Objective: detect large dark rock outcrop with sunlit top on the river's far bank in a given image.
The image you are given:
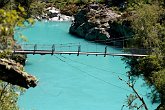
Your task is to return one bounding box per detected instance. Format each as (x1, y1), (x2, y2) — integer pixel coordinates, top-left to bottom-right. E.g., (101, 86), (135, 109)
(69, 4), (120, 40)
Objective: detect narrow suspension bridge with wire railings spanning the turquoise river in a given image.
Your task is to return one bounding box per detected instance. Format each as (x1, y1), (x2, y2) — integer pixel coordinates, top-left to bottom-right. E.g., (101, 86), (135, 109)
(12, 43), (148, 57)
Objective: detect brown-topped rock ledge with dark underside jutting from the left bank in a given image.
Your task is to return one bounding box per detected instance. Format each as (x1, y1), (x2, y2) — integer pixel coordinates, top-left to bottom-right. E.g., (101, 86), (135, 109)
(0, 59), (38, 89)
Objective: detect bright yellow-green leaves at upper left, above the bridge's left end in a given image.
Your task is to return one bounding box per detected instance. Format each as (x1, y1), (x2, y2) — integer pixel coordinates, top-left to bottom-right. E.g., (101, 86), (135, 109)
(0, 8), (25, 49)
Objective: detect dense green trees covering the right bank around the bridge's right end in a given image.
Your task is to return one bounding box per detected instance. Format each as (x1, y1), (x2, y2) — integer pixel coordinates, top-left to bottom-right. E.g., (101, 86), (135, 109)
(120, 0), (165, 106)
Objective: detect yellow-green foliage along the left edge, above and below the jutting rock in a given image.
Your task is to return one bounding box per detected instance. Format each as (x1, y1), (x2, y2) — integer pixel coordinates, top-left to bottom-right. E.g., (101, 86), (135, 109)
(0, 0), (33, 110)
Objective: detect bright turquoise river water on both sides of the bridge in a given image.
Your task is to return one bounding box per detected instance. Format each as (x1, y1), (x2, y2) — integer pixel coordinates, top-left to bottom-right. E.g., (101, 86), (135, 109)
(16, 22), (156, 110)
